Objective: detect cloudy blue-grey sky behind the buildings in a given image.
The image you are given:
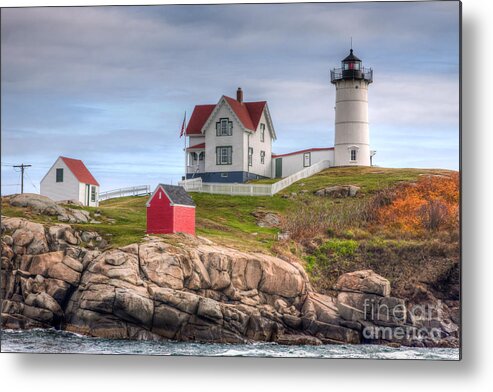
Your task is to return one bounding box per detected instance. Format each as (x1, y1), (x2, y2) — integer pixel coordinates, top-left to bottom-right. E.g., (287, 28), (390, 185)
(1, 1), (459, 195)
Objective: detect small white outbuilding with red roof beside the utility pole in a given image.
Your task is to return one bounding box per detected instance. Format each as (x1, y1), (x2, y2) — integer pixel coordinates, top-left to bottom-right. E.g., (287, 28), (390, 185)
(40, 157), (99, 207)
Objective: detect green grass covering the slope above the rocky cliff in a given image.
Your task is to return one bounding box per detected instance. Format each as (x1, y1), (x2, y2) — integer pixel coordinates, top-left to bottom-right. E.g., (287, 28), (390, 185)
(2, 167), (458, 252)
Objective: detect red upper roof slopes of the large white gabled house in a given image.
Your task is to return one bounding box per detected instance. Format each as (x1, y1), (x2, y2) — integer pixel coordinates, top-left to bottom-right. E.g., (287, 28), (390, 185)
(187, 96), (267, 135)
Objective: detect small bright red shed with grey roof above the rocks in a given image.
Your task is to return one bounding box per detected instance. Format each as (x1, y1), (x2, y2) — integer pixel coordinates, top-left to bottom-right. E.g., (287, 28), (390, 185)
(147, 184), (195, 235)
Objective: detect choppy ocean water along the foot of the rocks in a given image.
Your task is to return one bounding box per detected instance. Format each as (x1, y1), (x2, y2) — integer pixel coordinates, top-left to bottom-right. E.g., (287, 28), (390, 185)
(1, 330), (459, 360)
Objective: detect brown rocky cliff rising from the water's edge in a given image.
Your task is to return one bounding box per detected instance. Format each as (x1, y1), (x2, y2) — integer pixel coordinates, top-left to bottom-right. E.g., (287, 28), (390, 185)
(0, 217), (458, 346)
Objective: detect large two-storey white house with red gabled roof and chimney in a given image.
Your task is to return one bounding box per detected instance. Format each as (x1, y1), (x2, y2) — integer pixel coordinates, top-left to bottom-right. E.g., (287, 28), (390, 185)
(186, 88), (276, 182)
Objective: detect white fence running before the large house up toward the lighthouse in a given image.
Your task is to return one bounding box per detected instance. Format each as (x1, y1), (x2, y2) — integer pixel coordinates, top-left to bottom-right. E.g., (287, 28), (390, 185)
(178, 161), (330, 196)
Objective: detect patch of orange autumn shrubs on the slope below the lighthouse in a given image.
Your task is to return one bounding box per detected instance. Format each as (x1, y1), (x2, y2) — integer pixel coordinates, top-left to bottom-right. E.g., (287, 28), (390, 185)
(377, 173), (459, 232)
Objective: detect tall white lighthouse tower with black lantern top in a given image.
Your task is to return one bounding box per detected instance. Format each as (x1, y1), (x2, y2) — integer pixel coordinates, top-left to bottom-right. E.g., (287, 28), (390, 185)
(330, 49), (373, 166)
